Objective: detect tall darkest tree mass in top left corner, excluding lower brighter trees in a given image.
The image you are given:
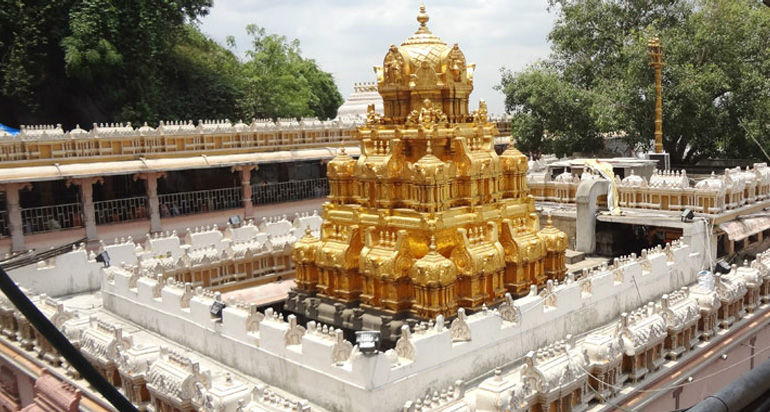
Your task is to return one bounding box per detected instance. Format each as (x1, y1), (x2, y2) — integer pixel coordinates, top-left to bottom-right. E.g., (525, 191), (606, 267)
(0, 0), (216, 127)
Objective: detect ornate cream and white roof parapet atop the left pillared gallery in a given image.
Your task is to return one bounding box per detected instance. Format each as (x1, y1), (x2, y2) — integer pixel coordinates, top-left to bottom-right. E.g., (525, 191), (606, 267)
(0, 117), (510, 167)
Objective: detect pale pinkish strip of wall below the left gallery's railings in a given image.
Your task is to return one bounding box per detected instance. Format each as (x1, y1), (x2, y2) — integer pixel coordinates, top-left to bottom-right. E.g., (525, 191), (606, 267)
(0, 198), (326, 256)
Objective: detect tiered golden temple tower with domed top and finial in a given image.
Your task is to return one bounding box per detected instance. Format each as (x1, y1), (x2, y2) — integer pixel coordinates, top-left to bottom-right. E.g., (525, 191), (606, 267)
(293, 6), (567, 318)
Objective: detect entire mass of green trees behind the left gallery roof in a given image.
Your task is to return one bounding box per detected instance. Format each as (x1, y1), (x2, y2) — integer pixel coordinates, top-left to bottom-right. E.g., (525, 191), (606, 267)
(0, 0), (342, 127)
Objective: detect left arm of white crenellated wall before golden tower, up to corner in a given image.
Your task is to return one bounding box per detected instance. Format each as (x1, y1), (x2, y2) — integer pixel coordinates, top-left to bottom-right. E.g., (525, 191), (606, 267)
(102, 275), (378, 410)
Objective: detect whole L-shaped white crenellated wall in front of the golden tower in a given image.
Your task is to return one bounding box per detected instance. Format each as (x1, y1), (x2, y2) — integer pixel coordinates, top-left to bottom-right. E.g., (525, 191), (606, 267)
(102, 238), (703, 411)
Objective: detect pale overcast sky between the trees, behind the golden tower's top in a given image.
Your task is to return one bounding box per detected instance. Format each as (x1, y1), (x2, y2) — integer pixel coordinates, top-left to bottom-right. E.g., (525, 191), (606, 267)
(201, 0), (554, 114)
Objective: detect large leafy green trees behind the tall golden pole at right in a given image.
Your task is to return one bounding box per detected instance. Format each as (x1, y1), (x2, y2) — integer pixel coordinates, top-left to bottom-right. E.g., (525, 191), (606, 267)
(500, 0), (770, 163)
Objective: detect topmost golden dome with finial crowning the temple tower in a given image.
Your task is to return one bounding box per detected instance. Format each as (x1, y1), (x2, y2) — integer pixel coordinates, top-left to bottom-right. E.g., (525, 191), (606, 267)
(374, 6), (475, 124)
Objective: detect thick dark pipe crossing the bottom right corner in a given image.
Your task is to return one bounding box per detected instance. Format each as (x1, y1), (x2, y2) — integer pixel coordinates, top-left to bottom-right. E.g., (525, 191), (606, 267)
(687, 360), (770, 412)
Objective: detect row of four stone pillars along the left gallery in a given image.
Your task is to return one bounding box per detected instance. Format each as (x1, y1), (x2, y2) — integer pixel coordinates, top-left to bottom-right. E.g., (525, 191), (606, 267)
(0, 165), (257, 252)
